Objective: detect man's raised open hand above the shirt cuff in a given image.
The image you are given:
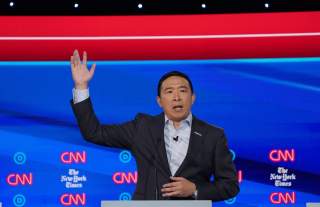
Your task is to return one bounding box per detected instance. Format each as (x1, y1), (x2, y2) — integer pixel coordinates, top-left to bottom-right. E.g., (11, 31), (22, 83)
(70, 50), (96, 89)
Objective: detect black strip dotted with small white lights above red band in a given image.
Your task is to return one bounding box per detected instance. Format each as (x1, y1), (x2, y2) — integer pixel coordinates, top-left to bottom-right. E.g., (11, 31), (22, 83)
(0, 0), (320, 15)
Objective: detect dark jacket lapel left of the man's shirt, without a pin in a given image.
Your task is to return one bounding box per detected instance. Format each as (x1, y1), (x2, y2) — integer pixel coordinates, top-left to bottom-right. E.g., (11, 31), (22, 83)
(151, 113), (171, 175)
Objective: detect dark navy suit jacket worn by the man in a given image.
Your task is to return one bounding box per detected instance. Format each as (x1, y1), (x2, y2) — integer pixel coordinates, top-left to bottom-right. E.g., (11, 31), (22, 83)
(71, 98), (239, 201)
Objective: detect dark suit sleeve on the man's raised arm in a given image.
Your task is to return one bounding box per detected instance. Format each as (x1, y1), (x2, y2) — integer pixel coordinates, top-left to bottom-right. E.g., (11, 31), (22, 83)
(71, 98), (137, 149)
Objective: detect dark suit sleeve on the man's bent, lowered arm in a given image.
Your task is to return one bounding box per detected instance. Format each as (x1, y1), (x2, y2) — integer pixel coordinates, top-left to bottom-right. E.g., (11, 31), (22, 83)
(197, 133), (240, 201)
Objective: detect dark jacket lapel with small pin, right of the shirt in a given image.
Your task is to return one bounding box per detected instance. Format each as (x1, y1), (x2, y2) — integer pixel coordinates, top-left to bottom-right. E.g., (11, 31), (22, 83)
(174, 116), (205, 176)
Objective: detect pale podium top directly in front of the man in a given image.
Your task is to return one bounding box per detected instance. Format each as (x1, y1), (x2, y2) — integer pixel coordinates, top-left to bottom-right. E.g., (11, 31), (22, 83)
(101, 200), (212, 207)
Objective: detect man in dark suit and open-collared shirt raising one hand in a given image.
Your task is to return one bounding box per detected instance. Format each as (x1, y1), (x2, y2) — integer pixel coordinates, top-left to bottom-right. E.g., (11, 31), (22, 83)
(71, 50), (239, 201)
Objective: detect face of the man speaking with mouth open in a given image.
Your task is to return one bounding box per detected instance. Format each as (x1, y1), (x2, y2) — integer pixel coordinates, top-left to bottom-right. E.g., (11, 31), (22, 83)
(157, 76), (195, 122)
